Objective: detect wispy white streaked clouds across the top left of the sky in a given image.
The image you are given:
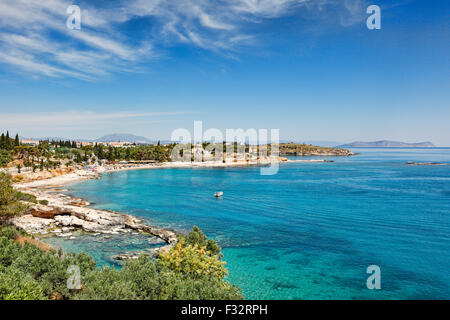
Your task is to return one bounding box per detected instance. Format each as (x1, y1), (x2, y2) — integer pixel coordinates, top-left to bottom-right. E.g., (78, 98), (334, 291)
(0, 0), (363, 81)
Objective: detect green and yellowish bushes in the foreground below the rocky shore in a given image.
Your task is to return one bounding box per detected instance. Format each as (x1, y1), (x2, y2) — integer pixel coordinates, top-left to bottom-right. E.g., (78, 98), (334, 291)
(0, 226), (242, 300)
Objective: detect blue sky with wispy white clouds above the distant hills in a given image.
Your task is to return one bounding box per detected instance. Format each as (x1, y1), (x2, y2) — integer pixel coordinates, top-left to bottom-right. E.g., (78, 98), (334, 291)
(0, 0), (450, 146)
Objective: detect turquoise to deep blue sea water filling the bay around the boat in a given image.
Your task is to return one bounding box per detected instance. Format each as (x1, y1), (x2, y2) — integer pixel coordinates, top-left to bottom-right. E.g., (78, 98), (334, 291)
(43, 149), (450, 299)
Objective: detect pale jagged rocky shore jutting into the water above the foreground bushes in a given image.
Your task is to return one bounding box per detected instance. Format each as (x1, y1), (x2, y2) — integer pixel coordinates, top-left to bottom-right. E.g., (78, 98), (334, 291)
(11, 177), (178, 260)
